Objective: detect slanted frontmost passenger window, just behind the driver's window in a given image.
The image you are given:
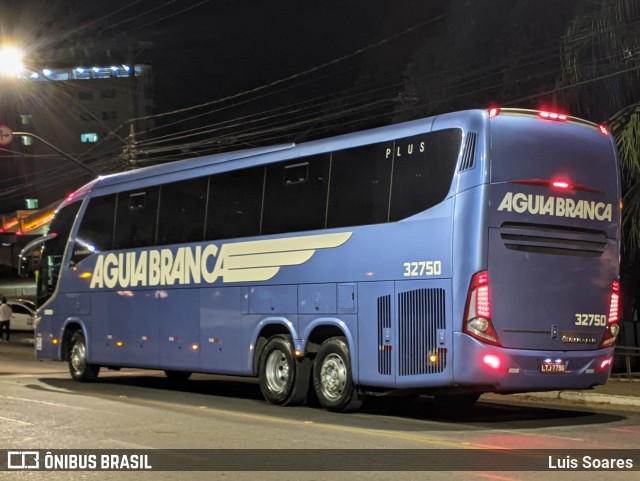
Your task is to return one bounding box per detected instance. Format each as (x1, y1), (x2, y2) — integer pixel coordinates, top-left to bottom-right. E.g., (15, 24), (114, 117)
(71, 194), (116, 263)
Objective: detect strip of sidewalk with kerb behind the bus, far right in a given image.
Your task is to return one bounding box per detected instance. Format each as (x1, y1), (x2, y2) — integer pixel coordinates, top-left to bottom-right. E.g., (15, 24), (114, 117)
(500, 374), (640, 409)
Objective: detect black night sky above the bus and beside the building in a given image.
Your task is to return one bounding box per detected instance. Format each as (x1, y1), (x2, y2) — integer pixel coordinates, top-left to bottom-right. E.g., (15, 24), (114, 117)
(0, 0), (639, 208)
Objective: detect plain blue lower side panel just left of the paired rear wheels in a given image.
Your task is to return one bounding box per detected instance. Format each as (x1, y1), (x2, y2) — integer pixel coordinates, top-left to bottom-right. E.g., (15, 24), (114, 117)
(199, 287), (250, 374)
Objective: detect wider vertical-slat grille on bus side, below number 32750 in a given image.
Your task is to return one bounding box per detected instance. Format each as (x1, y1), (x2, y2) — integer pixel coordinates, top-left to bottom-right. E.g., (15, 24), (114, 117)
(398, 289), (447, 376)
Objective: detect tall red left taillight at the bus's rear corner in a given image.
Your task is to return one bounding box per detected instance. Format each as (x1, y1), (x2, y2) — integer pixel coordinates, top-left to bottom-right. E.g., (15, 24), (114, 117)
(462, 271), (501, 346)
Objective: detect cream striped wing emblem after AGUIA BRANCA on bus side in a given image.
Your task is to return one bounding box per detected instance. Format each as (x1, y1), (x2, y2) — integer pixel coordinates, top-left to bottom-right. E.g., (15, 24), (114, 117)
(214, 232), (352, 282)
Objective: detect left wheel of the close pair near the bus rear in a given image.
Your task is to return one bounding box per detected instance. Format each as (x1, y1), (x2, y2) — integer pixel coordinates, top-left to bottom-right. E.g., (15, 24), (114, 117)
(258, 335), (296, 406)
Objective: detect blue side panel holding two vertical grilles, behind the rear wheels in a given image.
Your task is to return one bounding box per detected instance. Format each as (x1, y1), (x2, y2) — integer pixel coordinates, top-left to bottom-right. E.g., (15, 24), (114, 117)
(358, 279), (452, 389)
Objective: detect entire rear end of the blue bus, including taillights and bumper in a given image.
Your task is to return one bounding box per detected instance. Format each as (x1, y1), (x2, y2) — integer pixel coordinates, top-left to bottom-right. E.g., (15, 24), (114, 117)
(454, 110), (621, 392)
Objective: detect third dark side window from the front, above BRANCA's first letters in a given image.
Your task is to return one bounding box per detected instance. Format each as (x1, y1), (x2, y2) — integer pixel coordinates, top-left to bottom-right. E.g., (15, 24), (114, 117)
(158, 177), (208, 245)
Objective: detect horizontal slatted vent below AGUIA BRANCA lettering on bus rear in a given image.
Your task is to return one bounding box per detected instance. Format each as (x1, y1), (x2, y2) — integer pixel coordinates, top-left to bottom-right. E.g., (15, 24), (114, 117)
(500, 222), (607, 257)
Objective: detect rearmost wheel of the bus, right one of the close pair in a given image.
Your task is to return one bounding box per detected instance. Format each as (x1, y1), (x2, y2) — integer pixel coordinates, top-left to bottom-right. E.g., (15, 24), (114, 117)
(313, 337), (362, 412)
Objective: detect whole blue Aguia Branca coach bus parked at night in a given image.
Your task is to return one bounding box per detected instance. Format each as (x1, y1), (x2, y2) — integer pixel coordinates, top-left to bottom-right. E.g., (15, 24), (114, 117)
(22, 109), (621, 411)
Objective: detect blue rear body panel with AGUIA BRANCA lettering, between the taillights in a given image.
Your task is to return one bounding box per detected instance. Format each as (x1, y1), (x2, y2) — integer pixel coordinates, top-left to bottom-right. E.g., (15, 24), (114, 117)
(480, 115), (620, 351)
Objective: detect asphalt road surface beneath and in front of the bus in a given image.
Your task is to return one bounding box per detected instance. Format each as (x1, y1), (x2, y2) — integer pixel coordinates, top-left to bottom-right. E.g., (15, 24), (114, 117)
(0, 335), (640, 481)
